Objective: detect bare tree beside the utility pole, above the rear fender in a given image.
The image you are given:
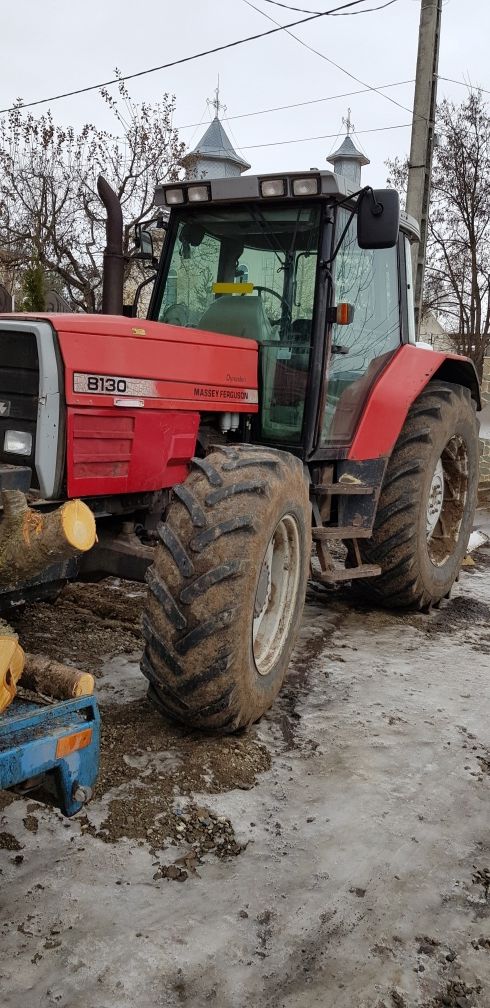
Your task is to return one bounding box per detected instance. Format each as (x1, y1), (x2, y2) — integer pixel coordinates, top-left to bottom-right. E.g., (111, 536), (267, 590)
(388, 92), (490, 375)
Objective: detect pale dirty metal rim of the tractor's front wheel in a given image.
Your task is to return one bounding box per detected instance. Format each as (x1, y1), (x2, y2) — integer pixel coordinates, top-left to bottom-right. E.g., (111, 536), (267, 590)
(252, 514), (300, 675)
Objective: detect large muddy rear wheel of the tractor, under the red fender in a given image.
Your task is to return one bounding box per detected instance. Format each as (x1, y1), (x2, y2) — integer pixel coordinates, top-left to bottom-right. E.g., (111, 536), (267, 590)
(347, 381), (479, 611)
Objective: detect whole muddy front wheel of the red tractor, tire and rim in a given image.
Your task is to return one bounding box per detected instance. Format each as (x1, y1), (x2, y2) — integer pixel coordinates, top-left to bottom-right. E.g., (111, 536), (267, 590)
(141, 445), (312, 734)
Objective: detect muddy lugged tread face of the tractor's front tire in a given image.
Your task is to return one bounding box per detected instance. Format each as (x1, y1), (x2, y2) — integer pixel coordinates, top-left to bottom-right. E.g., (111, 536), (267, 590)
(141, 446), (310, 733)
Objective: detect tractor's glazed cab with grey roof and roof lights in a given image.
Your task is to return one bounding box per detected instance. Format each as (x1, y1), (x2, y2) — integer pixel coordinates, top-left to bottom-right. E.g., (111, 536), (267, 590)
(149, 171), (416, 458)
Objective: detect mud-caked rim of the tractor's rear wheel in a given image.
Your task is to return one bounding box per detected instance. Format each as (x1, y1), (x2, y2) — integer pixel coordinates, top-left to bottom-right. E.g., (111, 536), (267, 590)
(425, 434), (469, 566)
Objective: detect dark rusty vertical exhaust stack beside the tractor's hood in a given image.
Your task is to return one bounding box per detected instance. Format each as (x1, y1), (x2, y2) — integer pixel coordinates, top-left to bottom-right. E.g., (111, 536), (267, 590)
(97, 175), (125, 314)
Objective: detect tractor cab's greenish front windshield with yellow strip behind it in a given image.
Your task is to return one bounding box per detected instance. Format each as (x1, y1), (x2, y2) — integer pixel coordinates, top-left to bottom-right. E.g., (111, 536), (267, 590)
(156, 203), (321, 444)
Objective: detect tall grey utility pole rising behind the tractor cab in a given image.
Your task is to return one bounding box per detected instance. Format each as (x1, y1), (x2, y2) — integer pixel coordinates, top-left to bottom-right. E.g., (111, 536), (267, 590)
(406, 0), (443, 334)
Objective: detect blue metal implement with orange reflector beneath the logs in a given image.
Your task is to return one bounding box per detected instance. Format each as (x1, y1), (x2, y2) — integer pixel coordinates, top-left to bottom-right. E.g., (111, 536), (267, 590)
(0, 696), (100, 815)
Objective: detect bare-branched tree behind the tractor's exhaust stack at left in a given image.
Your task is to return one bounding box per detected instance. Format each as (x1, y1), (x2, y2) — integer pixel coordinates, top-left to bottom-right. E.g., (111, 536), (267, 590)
(0, 74), (185, 311)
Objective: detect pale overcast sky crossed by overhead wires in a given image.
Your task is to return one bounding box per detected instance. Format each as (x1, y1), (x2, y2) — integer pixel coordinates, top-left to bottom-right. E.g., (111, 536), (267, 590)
(0, 0), (490, 185)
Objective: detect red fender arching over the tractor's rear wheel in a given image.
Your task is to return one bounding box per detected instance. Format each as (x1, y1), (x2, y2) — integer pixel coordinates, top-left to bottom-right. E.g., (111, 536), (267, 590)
(348, 344), (481, 462)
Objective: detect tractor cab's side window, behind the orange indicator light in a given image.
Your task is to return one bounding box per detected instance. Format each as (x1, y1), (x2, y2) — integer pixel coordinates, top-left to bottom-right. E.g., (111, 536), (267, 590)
(323, 208), (401, 444)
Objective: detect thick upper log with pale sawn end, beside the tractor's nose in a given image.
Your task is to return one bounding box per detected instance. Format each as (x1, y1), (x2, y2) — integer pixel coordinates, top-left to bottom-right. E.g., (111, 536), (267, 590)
(0, 490), (97, 589)
